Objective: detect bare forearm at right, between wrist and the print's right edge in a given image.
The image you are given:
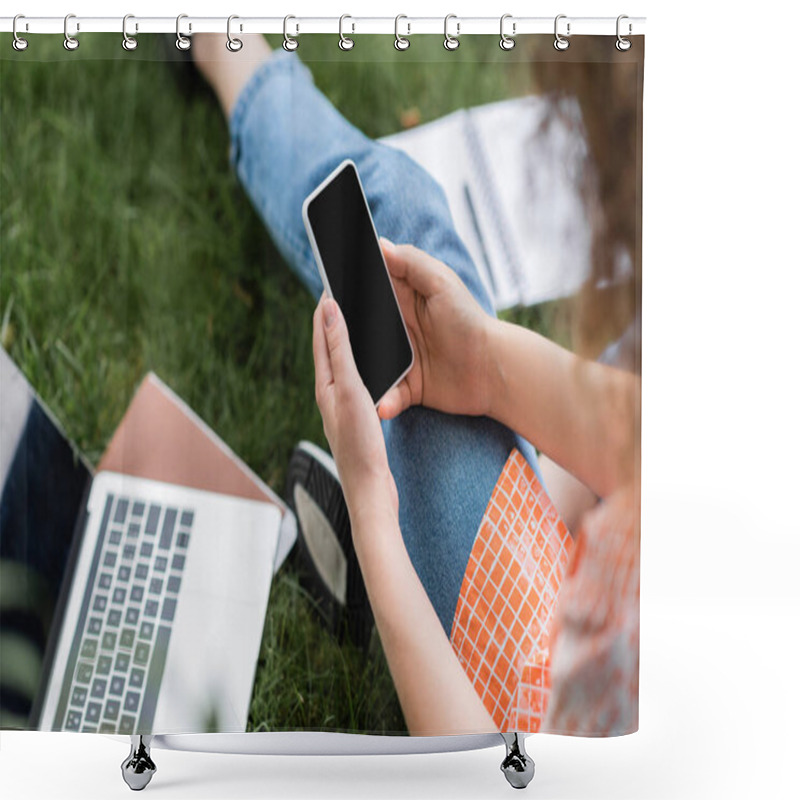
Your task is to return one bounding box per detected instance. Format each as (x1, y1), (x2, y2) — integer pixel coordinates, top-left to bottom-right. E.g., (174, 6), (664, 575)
(489, 321), (640, 497)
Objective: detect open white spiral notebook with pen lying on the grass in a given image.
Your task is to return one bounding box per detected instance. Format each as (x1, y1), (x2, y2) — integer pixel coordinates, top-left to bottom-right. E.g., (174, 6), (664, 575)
(382, 95), (608, 310)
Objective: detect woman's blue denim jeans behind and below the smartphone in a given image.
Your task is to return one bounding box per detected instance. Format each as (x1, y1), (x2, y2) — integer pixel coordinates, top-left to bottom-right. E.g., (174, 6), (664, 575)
(230, 51), (541, 635)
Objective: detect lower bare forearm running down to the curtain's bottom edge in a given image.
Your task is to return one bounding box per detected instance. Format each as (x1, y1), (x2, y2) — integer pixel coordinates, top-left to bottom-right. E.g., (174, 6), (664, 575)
(352, 508), (497, 735)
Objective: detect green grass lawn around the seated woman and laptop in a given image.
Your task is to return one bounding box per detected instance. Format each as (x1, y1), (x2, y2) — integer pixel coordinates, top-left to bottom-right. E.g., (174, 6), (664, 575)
(0, 35), (564, 732)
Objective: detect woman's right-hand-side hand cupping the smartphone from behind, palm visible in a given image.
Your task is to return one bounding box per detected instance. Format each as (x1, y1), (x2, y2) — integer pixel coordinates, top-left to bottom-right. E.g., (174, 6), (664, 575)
(378, 239), (494, 419)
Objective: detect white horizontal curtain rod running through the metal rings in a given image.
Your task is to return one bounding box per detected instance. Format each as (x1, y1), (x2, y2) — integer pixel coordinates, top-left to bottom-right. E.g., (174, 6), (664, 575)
(0, 14), (645, 37)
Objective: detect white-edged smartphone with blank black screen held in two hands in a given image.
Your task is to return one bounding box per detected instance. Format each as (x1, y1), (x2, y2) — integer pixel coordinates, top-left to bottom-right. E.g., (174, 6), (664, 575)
(303, 159), (414, 405)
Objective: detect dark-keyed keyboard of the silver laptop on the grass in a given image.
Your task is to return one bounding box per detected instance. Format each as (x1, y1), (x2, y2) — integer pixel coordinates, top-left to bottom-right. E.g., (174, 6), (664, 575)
(54, 495), (194, 734)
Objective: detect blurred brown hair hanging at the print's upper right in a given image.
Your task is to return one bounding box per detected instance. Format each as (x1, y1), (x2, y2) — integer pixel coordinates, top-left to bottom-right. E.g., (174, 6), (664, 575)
(530, 36), (644, 366)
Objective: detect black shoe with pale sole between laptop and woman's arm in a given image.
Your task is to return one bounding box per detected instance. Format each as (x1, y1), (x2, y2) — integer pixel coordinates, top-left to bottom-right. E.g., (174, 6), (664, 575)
(286, 442), (373, 650)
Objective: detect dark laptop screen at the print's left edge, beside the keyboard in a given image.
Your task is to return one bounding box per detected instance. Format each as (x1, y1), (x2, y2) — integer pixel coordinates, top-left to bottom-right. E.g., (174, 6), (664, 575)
(0, 348), (91, 728)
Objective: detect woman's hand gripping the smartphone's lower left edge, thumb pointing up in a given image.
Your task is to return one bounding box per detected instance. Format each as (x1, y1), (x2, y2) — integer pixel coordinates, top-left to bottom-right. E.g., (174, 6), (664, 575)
(313, 294), (398, 532)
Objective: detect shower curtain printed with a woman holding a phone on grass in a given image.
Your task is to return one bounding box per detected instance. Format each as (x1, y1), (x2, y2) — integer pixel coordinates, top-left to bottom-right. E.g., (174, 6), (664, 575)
(0, 25), (644, 736)
